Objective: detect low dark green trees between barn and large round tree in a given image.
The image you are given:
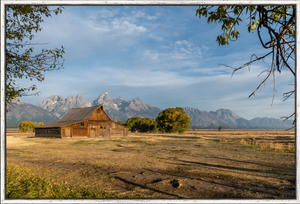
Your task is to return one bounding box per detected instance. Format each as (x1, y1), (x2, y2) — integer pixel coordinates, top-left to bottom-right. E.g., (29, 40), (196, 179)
(123, 117), (157, 132)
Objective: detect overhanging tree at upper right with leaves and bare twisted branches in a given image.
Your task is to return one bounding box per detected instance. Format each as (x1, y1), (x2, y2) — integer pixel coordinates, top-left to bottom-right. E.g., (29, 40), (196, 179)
(196, 5), (296, 123)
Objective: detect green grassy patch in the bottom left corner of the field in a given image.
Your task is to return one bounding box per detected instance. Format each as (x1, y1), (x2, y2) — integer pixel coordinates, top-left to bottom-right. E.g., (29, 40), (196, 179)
(6, 165), (136, 198)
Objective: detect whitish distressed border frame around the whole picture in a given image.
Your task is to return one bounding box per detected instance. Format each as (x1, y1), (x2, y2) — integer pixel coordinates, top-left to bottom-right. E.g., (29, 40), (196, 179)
(0, 0), (300, 203)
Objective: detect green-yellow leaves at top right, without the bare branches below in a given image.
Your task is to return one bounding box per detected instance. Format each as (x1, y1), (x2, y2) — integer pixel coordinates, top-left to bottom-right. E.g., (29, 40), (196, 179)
(196, 5), (295, 45)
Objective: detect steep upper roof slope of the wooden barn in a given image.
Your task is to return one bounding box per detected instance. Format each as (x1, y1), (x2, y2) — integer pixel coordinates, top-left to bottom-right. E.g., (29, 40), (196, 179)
(59, 105), (103, 122)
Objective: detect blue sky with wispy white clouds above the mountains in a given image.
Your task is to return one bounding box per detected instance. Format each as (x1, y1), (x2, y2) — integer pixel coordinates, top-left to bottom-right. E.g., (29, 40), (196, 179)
(18, 6), (294, 119)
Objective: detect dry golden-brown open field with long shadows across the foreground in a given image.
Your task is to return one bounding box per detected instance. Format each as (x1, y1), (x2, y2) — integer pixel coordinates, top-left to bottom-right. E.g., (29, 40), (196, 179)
(6, 130), (295, 199)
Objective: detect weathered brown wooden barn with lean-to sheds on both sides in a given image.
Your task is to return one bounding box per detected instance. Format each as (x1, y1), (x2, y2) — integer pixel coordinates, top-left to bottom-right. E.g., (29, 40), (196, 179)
(35, 105), (128, 139)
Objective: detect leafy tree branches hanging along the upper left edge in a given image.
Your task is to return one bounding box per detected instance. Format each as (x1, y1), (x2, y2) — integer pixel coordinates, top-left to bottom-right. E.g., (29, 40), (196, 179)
(5, 5), (65, 105)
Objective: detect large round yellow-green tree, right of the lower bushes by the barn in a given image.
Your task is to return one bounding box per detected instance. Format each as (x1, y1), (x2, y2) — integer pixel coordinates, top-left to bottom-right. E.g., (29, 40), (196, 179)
(156, 107), (191, 133)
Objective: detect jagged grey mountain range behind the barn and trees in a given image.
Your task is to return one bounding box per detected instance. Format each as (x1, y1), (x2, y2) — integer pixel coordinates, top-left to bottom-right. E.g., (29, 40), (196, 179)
(7, 91), (292, 129)
